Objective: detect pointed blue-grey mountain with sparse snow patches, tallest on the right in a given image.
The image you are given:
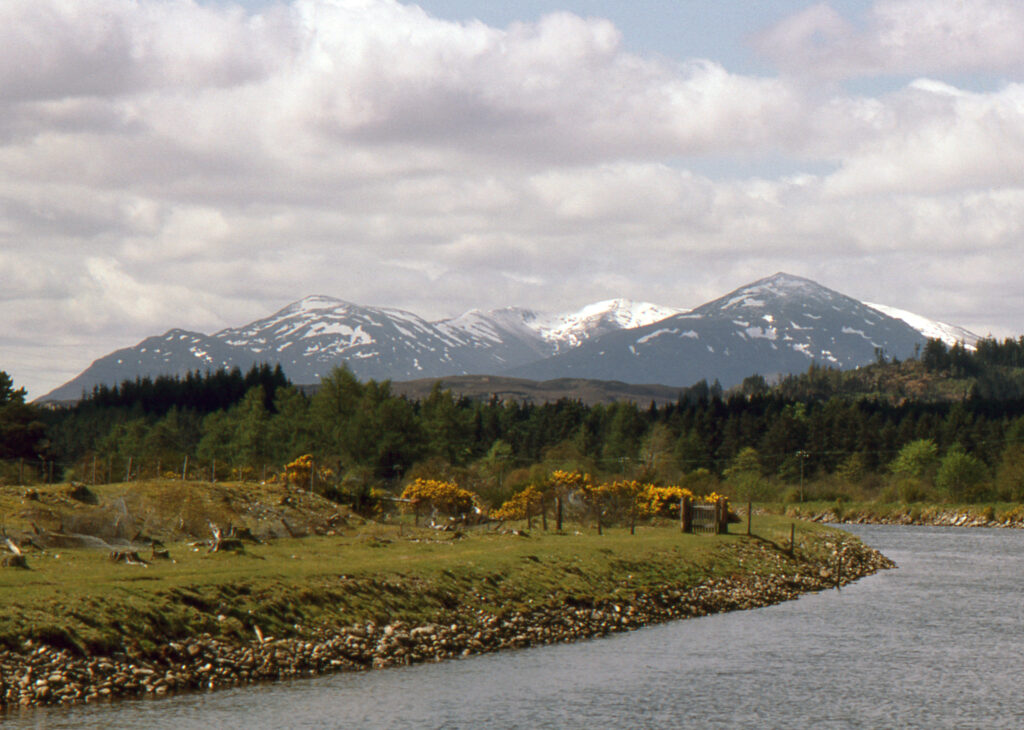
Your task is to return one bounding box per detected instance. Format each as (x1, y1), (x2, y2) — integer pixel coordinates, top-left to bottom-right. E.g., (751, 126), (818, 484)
(510, 273), (942, 387)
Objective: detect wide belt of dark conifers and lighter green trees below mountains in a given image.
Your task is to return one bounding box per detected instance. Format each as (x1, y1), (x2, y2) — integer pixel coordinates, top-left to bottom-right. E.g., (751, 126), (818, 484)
(6, 338), (1024, 508)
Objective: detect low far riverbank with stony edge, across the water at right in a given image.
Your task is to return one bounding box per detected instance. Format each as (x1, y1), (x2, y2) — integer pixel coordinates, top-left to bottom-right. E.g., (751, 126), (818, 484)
(774, 502), (1024, 529)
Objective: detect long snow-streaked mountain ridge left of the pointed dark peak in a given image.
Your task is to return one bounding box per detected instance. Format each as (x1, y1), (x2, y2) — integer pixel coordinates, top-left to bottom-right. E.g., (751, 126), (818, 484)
(42, 296), (671, 400)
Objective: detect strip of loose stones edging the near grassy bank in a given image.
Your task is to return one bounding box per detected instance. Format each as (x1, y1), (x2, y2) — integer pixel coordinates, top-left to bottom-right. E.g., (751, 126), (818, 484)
(0, 541), (894, 712)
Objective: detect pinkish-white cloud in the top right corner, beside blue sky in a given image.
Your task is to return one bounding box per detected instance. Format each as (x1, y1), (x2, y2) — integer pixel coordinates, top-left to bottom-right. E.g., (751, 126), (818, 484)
(757, 0), (1024, 79)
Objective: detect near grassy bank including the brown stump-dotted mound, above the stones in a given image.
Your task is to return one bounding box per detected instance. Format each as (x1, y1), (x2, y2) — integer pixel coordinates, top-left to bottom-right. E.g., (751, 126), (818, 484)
(0, 482), (868, 653)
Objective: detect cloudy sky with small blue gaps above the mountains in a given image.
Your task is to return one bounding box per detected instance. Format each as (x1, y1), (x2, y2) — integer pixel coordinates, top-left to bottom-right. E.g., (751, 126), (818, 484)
(6, 0), (1024, 397)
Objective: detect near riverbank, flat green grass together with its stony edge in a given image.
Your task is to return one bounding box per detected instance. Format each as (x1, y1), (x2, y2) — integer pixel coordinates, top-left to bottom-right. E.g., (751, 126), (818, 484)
(0, 511), (891, 710)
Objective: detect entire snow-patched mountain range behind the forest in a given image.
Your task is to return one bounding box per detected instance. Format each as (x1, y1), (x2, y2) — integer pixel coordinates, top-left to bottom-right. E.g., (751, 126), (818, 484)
(40, 273), (978, 401)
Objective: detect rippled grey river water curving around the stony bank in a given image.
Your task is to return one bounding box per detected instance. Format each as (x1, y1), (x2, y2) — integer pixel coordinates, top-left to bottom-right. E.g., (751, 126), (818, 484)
(4, 526), (1024, 730)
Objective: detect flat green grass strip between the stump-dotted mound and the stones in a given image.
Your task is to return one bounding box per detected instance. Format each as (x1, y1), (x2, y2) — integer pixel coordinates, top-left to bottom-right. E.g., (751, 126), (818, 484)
(0, 517), (835, 653)
